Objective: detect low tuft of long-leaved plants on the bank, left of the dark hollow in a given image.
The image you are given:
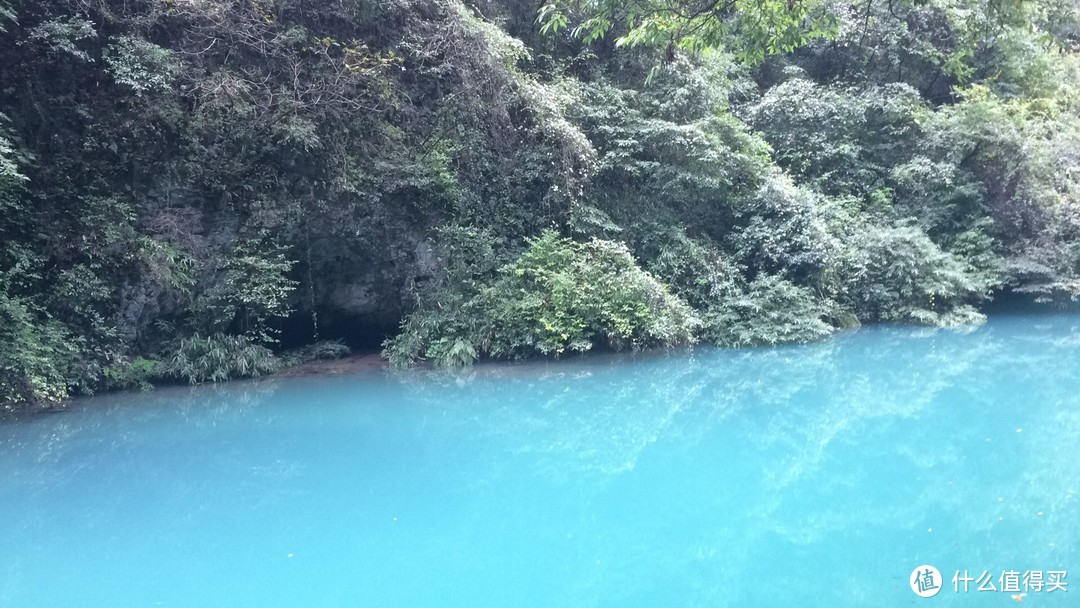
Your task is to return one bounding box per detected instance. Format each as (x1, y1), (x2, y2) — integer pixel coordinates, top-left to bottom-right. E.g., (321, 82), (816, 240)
(161, 334), (281, 384)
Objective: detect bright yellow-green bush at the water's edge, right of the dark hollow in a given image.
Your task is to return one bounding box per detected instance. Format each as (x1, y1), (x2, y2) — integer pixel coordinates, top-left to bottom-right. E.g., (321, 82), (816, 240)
(384, 231), (700, 366)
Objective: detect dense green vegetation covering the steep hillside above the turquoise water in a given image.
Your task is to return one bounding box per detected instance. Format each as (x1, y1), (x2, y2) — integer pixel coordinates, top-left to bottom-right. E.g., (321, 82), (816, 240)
(0, 0), (1080, 410)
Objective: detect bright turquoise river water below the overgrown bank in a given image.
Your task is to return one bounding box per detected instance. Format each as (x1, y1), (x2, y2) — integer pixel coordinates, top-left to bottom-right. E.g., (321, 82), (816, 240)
(0, 315), (1080, 608)
